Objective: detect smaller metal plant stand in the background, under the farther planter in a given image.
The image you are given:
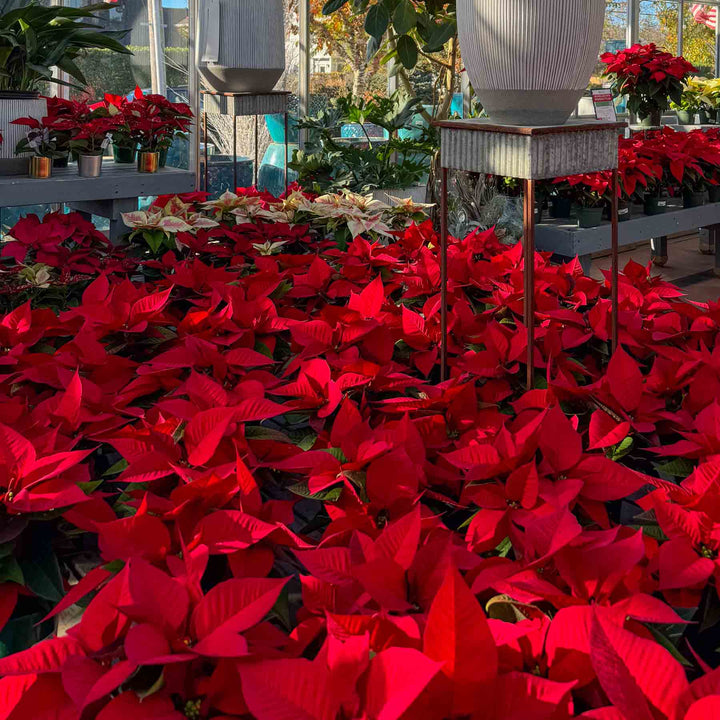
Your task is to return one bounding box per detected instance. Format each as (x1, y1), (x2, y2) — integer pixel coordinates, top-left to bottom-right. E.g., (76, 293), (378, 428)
(198, 90), (290, 192)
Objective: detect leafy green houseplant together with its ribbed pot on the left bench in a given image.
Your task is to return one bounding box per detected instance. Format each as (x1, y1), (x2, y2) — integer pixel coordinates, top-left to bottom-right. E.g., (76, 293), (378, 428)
(0, 0), (130, 174)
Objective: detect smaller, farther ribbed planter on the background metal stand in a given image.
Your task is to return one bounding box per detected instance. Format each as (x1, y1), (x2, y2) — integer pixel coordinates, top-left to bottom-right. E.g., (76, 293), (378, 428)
(197, 0), (285, 93)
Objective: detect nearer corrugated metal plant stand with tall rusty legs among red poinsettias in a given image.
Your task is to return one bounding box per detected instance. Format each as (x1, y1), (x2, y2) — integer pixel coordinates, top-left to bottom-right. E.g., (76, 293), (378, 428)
(435, 118), (625, 389)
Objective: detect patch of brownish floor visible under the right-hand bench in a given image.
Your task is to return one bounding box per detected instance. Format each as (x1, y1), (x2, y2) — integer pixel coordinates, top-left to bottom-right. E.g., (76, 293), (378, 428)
(590, 235), (720, 302)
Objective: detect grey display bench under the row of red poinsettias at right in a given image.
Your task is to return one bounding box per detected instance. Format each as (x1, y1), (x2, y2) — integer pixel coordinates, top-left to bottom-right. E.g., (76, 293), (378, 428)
(535, 203), (720, 272)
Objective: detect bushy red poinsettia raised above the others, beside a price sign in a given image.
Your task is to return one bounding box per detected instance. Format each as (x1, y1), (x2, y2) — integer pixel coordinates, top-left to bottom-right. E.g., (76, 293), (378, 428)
(600, 43), (697, 126)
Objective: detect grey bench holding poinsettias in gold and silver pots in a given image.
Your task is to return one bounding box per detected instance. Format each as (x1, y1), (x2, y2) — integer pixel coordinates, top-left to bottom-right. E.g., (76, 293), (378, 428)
(0, 162), (195, 239)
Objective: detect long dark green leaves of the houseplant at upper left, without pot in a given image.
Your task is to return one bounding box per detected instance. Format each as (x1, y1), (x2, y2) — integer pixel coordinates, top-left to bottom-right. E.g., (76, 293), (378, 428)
(0, 2), (130, 92)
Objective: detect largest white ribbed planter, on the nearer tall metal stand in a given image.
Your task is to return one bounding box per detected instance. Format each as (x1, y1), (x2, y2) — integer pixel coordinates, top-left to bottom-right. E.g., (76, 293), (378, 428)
(457, 0), (605, 125)
